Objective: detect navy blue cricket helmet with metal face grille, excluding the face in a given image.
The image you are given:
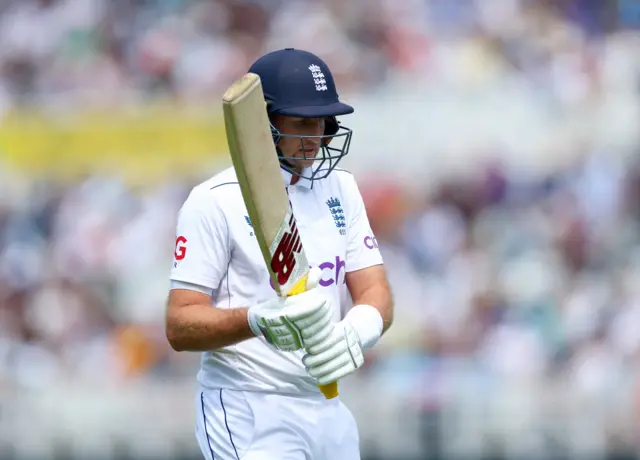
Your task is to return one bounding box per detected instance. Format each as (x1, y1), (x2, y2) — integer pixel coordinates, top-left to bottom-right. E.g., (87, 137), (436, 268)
(249, 48), (353, 181)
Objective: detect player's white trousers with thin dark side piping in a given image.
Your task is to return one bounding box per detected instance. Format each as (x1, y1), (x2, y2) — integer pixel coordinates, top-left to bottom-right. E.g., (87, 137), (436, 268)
(195, 390), (360, 460)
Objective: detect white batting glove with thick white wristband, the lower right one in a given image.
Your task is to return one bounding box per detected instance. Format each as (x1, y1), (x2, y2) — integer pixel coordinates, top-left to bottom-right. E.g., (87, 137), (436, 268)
(302, 305), (383, 385)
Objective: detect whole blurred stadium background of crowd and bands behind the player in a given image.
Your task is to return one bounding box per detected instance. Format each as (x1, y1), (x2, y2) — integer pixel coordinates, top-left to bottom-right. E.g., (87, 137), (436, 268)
(0, 0), (640, 460)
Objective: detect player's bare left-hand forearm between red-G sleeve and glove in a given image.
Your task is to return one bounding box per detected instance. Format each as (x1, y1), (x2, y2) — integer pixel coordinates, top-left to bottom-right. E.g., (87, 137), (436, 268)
(166, 305), (255, 351)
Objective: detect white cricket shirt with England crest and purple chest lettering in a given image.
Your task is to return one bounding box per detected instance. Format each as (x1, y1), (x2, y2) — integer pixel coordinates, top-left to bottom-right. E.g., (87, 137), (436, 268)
(171, 168), (382, 393)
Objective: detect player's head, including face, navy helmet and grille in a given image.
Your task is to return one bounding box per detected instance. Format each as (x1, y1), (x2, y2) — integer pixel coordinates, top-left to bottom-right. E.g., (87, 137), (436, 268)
(249, 48), (353, 181)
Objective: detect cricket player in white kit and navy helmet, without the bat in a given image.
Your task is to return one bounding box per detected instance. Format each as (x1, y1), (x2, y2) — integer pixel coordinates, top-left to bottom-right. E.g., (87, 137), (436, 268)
(166, 49), (393, 460)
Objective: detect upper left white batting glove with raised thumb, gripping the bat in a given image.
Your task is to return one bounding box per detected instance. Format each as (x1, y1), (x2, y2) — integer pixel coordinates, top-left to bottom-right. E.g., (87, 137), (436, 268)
(248, 267), (333, 351)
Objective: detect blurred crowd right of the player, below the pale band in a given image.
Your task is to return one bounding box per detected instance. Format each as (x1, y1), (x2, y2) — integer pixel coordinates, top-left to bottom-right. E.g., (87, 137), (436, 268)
(365, 152), (640, 396)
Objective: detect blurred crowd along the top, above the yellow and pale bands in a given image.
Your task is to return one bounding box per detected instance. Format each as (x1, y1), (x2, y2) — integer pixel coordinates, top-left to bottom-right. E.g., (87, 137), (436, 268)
(0, 0), (637, 110)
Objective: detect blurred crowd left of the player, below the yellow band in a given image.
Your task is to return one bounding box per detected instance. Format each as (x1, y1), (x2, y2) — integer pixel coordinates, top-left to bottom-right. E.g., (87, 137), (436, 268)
(0, 166), (188, 388)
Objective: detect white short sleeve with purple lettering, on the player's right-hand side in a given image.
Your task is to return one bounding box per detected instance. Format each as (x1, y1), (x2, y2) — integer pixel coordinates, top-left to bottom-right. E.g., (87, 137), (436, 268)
(343, 173), (383, 272)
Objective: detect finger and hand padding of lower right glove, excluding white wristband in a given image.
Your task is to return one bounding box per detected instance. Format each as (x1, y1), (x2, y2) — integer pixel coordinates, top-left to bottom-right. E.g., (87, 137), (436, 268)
(302, 318), (364, 385)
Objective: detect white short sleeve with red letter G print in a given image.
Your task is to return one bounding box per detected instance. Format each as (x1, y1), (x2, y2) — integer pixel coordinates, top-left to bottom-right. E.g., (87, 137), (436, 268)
(170, 192), (230, 290)
